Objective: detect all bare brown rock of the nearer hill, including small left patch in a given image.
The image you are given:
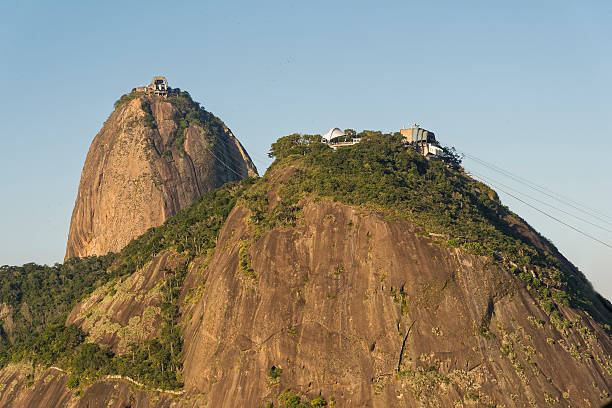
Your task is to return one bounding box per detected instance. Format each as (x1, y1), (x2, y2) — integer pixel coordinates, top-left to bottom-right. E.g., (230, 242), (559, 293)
(0, 164), (612, 408)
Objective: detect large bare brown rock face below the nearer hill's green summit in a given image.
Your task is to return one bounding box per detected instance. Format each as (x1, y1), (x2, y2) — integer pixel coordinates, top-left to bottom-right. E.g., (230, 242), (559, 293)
(173, 202), (612, 408)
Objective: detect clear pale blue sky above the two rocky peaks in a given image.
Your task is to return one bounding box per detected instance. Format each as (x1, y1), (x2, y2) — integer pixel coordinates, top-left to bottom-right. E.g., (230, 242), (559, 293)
(0, 0), (612, 299)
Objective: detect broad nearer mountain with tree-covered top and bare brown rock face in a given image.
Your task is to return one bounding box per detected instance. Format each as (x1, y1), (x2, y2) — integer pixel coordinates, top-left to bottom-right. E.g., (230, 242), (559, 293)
(0, 131), (612, 408)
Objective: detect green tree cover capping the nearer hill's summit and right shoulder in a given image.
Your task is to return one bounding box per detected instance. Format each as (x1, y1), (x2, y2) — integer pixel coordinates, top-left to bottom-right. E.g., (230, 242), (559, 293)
(266, 131), (606, 332)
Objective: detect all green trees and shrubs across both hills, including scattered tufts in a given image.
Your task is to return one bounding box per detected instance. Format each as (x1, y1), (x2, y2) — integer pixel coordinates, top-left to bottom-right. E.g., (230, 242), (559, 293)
(0, 128), (609, 396)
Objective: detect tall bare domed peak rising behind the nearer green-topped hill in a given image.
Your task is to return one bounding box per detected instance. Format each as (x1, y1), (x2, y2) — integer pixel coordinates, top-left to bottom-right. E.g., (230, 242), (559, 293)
(66, 83), (257, 259)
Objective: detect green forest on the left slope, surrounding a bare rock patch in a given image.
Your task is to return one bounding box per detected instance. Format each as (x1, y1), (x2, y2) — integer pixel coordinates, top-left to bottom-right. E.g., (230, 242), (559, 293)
(0, 179), (253, 389)
